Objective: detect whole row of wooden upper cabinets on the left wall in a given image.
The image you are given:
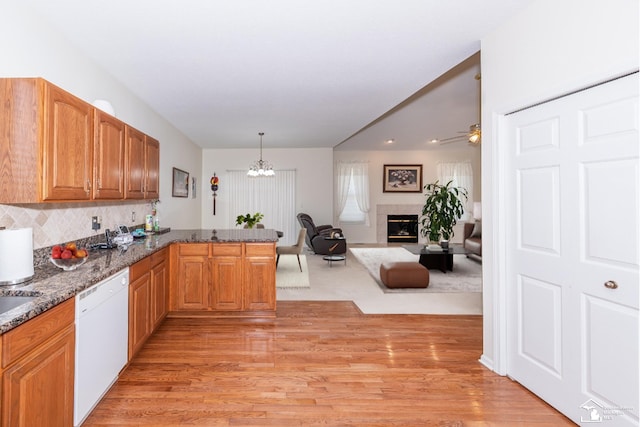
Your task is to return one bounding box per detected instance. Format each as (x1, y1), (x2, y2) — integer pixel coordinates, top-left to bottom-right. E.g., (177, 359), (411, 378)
(0, 78), (160, 204)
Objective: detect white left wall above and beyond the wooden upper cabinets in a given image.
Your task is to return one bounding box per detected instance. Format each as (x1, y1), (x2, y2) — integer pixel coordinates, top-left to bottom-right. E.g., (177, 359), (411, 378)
(0, 2), (201, 237)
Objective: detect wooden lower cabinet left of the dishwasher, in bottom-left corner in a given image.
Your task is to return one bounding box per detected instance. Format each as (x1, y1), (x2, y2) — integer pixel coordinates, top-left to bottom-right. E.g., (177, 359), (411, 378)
(1, 298), (75, 427)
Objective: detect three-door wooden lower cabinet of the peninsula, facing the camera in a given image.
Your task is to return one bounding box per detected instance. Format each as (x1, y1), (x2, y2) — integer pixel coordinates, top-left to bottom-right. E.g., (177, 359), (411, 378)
(169, 243), (276, 316)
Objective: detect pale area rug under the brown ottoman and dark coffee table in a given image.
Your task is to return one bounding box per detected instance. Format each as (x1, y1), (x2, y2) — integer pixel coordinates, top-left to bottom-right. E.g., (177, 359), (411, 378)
(349, 248), (482, 293)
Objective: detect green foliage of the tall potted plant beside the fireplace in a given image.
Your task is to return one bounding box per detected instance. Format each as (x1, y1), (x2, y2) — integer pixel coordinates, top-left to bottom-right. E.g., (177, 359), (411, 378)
(420, 181), (468, 249)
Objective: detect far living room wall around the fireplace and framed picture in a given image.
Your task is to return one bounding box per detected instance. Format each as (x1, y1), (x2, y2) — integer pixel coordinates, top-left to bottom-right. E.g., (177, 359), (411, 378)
(334, 148), (481, 243)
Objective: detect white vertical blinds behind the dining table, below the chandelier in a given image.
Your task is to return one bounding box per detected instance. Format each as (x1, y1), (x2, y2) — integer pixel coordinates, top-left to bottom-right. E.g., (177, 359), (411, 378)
(227, 170), (300, 245)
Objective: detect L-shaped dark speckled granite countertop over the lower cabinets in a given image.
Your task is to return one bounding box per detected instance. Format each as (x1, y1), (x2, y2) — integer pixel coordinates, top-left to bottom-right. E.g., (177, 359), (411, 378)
(0, 229), (278, 334)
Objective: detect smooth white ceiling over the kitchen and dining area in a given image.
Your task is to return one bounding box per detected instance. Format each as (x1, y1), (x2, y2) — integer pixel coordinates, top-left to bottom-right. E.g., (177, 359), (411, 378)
(23, 0), (531, 149)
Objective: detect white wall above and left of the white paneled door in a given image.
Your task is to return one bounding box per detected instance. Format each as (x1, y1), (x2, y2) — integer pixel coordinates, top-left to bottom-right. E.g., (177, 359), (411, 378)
(481, 0), (639, 373)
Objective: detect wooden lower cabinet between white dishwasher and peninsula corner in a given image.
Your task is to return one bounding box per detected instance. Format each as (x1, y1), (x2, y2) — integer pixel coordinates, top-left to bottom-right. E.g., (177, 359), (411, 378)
(129, 249), (169, 360)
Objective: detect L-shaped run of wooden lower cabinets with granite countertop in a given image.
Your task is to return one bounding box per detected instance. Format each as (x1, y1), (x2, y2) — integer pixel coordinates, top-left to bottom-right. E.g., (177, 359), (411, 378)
(0, 229), (278, 426)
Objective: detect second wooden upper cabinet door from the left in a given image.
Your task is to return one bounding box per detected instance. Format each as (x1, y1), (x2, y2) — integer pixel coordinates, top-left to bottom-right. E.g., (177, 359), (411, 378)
(93, 109), (125, 199)
